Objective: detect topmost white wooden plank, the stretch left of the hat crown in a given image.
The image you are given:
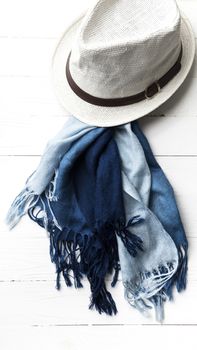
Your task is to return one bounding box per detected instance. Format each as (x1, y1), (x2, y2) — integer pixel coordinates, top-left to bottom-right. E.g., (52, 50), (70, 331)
(0, 0), (94, 39)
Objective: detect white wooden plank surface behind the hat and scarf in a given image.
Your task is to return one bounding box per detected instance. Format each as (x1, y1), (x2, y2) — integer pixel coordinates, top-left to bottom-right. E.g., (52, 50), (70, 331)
(0, 0), (197, 350)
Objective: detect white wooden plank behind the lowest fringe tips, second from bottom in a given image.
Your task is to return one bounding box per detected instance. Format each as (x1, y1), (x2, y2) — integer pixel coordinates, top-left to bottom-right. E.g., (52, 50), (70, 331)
(0, 281), (197, 326)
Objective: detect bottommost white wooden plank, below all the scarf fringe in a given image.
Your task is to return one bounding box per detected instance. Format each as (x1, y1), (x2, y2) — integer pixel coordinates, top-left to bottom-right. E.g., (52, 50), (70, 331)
(0, 325), (196, 350)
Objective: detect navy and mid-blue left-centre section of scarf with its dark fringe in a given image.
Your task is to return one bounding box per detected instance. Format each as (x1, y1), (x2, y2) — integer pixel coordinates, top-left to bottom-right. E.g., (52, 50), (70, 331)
(29, 128), (125, 314)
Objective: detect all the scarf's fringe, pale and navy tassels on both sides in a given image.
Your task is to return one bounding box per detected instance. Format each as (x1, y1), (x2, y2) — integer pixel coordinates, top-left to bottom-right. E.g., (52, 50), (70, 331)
(6, 188), (188, 322)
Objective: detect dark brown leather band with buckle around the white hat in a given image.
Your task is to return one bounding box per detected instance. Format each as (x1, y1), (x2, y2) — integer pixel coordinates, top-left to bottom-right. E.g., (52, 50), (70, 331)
(66, 45), (183, 107)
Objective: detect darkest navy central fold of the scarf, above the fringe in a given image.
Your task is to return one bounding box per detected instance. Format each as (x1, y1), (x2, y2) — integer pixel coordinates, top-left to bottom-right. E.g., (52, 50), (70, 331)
(73, 129), (125, 232)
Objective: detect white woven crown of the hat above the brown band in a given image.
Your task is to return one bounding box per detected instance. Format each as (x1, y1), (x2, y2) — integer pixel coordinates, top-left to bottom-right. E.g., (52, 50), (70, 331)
(70, 0), (181, 98)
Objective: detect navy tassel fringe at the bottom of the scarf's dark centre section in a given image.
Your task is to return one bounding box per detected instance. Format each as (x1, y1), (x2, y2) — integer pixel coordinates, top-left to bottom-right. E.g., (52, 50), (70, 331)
(50, 228), (117, 315)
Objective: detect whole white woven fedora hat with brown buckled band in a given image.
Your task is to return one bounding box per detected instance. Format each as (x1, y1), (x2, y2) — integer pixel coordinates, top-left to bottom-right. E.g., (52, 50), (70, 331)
(52, 0), (195, 127)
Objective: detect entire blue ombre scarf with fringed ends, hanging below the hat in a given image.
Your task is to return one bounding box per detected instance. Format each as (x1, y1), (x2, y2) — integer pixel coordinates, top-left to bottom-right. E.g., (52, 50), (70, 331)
(6, 117), (188, 322)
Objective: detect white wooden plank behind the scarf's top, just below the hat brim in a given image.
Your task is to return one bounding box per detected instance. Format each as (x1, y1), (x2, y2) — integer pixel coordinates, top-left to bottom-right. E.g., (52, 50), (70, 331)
(0, 114), (197, 156)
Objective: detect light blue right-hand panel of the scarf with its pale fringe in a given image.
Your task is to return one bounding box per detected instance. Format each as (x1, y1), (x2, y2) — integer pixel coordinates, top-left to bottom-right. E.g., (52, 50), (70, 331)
(114, 124), (178, 322)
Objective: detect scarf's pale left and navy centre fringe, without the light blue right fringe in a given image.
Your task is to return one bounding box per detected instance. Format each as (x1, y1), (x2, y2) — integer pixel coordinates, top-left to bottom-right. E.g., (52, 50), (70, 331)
(6, 188), (143, 316)
